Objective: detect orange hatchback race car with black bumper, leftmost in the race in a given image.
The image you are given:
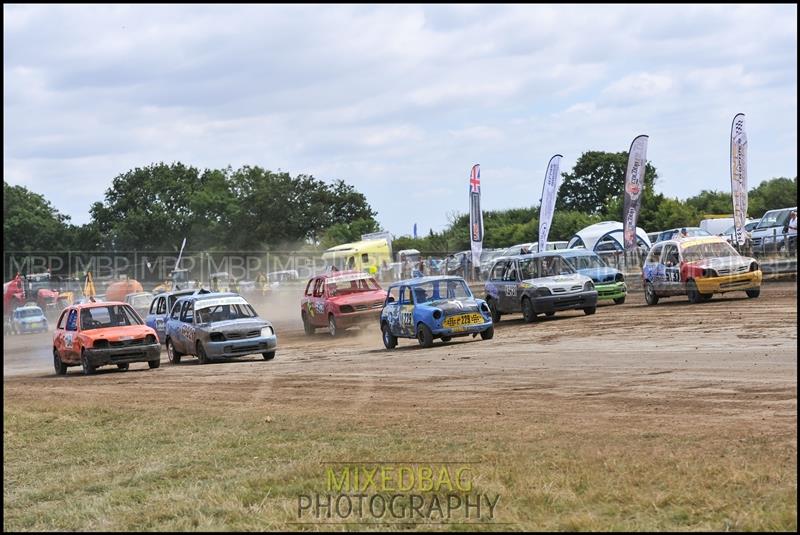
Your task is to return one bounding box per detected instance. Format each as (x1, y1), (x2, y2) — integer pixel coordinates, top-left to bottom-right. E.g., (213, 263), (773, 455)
(53, 301), (161, 375)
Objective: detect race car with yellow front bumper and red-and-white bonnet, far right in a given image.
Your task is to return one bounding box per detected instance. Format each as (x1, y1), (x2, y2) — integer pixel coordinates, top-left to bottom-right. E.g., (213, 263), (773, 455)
(642, 236), (762, 305)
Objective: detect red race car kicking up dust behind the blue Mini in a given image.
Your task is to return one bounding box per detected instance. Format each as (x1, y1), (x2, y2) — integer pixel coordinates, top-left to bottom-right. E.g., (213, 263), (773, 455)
(300, 271), (386, 336)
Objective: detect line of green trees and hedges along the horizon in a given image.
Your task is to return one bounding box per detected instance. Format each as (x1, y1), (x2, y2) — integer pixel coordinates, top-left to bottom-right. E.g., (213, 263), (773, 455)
(3, 151), (797, 253)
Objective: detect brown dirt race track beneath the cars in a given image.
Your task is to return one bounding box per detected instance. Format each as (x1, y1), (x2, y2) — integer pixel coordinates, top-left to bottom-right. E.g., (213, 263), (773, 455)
(3, 283), (797, 432)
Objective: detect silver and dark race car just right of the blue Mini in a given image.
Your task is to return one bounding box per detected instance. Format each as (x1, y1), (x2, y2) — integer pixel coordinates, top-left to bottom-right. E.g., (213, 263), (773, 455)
(485, 252), (597, 323)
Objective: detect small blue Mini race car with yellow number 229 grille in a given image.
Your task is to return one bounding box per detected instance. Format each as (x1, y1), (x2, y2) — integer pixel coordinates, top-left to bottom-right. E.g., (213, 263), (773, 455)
(380, 276), (494, 349)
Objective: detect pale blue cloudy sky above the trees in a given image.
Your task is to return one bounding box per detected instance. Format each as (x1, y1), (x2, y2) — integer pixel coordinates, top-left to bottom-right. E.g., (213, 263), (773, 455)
(3, 4), (797, 235)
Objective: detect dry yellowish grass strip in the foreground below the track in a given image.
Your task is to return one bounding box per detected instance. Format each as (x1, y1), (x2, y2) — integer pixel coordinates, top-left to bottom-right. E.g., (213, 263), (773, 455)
(3, 400), (797, 531)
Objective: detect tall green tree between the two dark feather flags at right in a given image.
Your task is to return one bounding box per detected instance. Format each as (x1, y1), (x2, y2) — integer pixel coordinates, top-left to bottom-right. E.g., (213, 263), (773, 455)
(556, 151), (658, 215)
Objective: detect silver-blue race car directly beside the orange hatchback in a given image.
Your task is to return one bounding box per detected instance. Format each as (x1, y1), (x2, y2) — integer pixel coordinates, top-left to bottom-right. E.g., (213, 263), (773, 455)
(165, 293), (278, 364)
